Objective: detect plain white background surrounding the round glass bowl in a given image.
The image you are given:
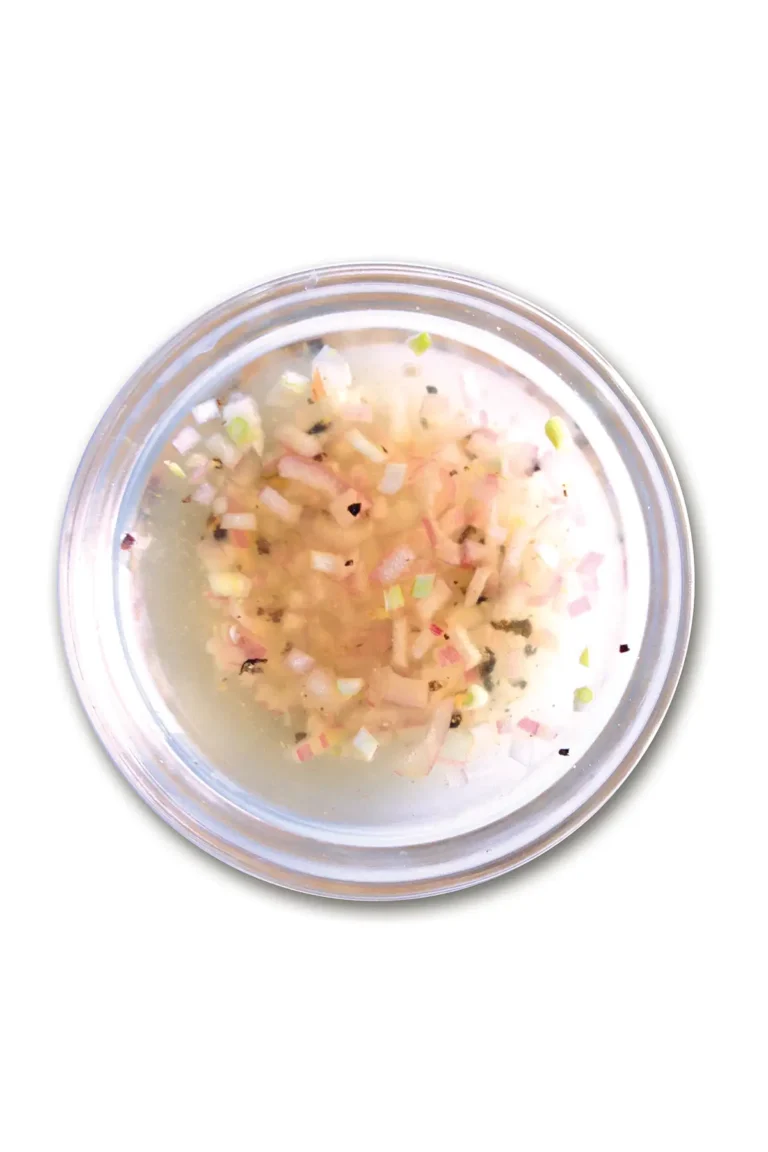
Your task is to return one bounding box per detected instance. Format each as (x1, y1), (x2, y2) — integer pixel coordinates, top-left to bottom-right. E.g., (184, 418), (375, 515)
(0, 0), (768, 1152)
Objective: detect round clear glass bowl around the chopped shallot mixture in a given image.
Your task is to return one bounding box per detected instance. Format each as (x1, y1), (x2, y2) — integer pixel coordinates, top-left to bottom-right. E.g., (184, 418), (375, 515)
(59, 264), (693, 900)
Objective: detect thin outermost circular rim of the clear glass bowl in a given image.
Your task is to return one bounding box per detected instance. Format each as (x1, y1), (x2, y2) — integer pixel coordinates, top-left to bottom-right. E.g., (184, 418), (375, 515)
(58, 262), (695, 901)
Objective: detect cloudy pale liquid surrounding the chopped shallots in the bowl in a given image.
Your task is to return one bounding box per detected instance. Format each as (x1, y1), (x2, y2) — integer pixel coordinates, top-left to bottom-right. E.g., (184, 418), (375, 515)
(122, 331), (639, 843)
